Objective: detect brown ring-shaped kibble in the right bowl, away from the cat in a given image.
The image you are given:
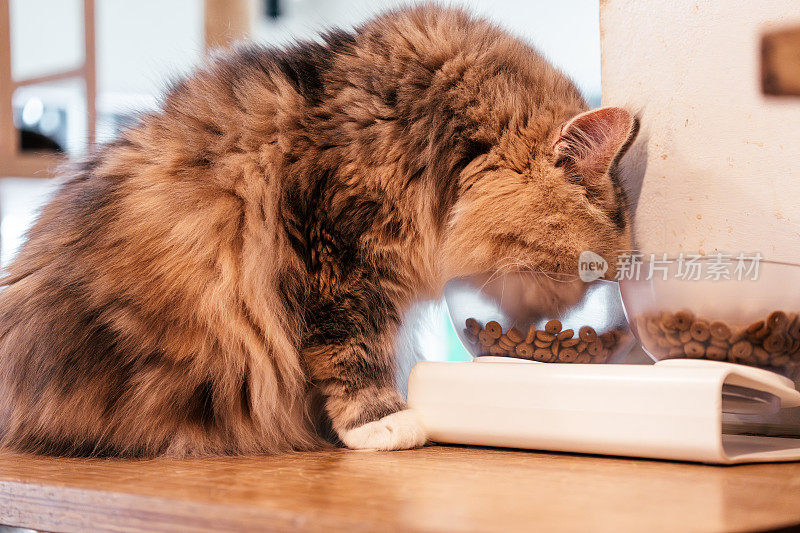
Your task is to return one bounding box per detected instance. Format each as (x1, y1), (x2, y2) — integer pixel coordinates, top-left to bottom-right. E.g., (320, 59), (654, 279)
(636, 311), (800, 368)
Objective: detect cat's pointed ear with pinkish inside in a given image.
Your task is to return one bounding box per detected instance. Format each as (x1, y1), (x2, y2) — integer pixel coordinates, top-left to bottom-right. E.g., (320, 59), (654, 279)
(553, 107), (639, 177)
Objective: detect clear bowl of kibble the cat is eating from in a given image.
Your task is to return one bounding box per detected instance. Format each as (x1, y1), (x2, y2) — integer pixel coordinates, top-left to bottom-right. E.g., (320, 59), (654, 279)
(445, 271), (635, 363)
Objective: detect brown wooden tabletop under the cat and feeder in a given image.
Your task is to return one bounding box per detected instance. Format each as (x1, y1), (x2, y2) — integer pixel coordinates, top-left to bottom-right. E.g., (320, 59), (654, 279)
(0, 446), (800, 532)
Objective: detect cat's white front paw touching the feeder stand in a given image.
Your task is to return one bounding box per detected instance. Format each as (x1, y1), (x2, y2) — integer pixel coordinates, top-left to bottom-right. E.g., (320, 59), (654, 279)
(340, 409), (428, 450)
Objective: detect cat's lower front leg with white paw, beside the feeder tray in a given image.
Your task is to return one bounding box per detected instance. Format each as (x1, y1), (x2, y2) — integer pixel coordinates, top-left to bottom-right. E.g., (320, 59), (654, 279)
(307, 332), (427, 450)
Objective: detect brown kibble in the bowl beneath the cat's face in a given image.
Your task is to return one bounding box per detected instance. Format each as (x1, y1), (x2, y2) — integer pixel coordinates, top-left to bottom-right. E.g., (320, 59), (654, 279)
(464, 318), (622, 363)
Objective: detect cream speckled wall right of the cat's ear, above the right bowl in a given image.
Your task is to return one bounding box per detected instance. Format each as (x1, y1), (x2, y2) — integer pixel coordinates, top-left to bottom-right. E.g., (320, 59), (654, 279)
(601, 0), (800, 261)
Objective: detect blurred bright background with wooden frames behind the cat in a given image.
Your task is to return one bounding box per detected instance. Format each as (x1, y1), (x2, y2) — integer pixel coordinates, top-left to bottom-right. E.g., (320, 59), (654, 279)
(0, 0), (600, 360)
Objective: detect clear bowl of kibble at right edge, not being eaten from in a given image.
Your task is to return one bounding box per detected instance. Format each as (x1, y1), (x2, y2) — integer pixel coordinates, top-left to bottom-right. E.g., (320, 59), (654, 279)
(620, 256), (800, 379)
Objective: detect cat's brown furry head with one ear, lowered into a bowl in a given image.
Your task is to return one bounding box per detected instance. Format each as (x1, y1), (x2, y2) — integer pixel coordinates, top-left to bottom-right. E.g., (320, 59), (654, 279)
(445, 107), (638, 278)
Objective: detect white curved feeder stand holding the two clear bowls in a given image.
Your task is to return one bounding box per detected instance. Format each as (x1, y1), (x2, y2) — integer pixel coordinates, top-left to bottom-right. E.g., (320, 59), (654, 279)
(408, 357), (800, 464)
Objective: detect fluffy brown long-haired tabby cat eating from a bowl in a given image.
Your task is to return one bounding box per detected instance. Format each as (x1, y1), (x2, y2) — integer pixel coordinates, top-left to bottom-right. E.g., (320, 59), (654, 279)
(0, 5), (637, 456)
